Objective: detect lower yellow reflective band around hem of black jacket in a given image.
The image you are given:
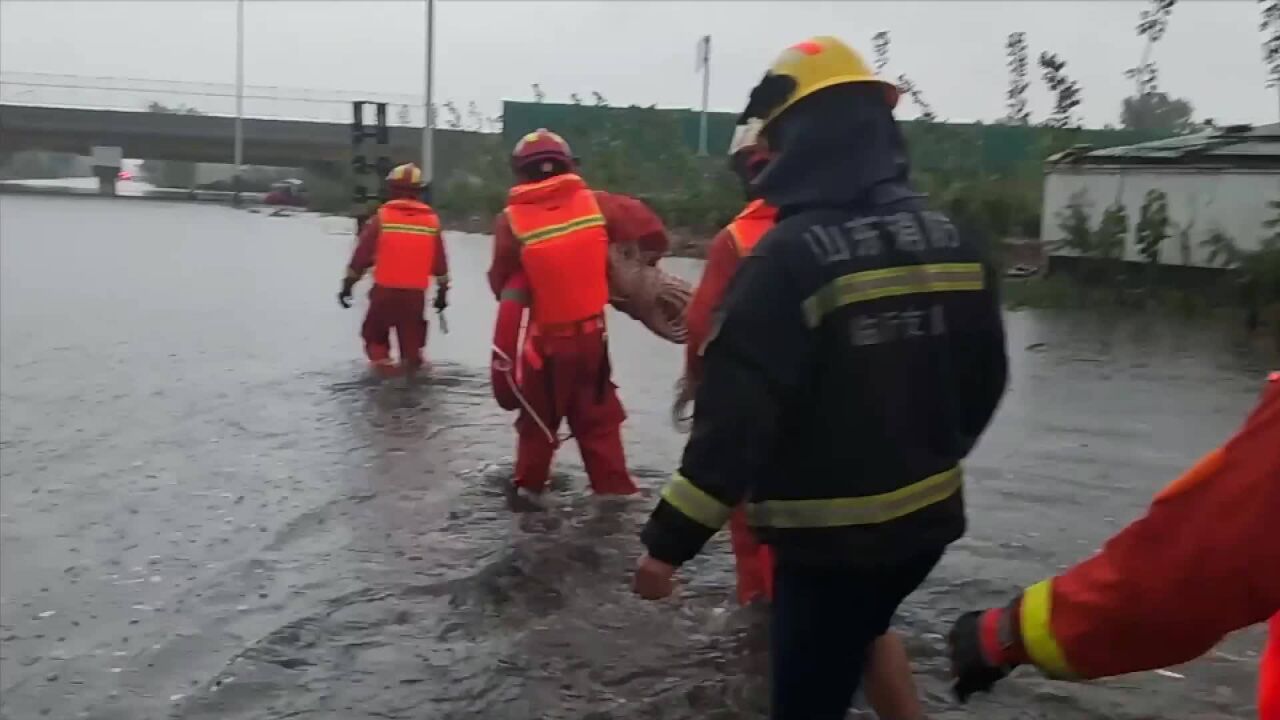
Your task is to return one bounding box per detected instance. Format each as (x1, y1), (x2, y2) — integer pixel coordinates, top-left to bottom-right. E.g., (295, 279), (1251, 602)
(746, 466), (964, 528)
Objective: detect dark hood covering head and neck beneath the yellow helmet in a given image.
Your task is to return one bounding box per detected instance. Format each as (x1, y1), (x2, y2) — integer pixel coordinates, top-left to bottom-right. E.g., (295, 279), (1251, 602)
(751, 83), (920, 215)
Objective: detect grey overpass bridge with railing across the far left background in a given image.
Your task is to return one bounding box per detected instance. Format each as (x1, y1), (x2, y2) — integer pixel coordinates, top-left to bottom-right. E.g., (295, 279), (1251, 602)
(0, 72), (494, 181)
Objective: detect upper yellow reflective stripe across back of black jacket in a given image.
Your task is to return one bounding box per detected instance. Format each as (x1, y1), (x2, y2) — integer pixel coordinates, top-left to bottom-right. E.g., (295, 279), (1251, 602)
(804, 263), (986, 328)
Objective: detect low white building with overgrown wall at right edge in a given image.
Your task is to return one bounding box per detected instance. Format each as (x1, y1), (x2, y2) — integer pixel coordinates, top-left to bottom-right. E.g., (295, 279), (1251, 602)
(1041, 123), (1280, 268)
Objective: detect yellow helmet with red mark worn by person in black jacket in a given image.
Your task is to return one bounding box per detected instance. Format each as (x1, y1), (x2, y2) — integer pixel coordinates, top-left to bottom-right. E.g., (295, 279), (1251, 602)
(758, 36), (899, 126)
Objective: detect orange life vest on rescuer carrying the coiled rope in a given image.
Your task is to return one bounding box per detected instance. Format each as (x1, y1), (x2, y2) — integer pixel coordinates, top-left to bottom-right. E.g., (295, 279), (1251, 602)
(507, 174), (609, 328)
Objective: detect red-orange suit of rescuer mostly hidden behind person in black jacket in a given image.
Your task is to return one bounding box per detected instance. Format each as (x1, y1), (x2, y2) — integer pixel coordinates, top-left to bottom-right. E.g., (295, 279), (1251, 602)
(685, 200), (778, 605)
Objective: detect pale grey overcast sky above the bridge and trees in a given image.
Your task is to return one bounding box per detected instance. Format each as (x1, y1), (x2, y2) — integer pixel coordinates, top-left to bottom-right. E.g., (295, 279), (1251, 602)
(0, 0), (1280, 126)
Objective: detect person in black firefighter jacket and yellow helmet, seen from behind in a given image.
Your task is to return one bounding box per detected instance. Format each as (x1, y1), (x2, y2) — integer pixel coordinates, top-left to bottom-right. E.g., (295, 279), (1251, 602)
(635, 37), (1007, 720)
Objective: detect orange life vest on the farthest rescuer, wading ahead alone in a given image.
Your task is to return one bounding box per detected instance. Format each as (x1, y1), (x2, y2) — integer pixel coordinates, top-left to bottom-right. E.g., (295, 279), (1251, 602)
(374, 200), (440, 290)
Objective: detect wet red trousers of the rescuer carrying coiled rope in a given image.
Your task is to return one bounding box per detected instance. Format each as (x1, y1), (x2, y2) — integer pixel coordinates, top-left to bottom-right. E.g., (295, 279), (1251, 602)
(516, 325), (636, 495)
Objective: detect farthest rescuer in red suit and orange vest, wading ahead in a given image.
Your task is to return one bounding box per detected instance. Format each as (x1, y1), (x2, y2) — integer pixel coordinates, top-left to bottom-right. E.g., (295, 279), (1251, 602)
(338, 163), (449, 378)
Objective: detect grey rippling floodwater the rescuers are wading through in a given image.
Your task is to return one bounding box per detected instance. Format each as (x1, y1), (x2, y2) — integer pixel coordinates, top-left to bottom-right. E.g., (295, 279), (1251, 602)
(0, 196), (1267, 720)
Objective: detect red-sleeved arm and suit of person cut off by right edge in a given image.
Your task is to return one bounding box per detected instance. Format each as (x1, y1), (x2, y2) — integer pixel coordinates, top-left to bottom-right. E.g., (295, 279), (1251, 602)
(950, 373), (1280, 720)
